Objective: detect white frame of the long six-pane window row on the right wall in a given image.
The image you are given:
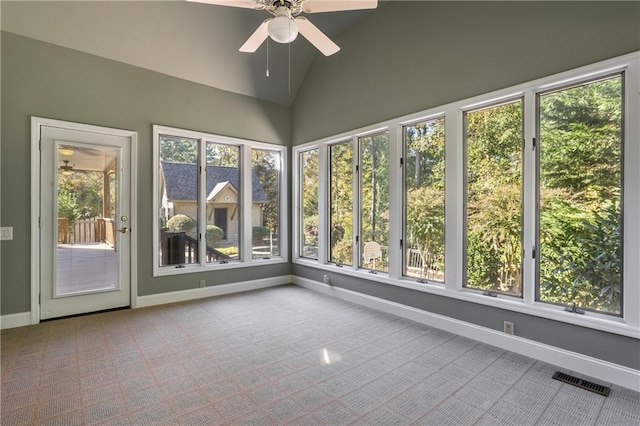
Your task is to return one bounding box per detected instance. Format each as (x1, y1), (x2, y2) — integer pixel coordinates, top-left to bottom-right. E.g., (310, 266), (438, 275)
(293, 51), (640, 339)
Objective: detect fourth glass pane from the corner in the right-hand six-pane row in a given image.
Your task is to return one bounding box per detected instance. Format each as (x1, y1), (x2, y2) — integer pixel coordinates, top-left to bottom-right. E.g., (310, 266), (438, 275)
(403, 118), (445, 282)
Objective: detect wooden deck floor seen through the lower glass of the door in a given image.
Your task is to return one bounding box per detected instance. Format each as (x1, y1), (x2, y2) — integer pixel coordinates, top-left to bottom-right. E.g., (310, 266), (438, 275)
(55, 243), (117, 295)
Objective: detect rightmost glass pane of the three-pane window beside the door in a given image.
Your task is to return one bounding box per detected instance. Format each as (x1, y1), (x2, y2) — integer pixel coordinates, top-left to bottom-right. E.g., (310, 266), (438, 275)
(251, 149), (282, 259)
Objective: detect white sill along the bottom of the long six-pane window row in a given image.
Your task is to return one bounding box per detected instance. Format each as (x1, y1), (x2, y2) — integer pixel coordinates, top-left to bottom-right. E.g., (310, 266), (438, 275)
(293, 259), (640, 339)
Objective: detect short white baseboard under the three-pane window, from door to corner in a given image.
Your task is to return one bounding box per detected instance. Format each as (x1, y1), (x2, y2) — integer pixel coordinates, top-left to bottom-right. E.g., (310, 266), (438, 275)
(136, 275), (291, 308)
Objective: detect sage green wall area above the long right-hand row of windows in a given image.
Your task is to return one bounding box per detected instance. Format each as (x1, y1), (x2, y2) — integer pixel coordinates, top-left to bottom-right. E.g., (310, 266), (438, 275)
(291, 0), (640, 145)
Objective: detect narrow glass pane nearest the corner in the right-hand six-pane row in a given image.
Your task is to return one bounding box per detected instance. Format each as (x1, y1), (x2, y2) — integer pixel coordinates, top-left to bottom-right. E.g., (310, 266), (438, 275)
(300, 149), (318, 259)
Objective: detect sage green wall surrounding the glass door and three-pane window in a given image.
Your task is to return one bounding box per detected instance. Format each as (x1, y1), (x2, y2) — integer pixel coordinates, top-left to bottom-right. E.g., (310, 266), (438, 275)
(0, 32), (290, 315)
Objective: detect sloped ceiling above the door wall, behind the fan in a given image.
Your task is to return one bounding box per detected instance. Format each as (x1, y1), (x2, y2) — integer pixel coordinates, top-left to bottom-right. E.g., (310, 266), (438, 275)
(1, 0), (378, 105)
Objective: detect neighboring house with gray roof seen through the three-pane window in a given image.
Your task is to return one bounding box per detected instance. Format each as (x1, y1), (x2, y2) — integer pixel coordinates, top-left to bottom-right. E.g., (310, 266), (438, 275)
(160, 161), (267, 244)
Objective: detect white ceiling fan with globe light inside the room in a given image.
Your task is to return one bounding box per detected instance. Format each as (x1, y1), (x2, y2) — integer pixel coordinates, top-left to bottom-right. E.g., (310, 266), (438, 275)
(187, 0), (378, 56)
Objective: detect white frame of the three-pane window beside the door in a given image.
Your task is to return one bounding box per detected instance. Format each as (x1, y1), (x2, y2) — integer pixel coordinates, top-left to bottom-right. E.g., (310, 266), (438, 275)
(152, 124), (289, 277)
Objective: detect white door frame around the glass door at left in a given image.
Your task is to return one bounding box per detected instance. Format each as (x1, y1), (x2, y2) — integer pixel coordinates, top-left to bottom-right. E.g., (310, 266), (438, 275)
(31, 116), (138, 324)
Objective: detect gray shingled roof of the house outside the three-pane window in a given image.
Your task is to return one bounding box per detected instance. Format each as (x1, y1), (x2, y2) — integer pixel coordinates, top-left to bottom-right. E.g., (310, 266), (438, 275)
(160, 161), (267, 203)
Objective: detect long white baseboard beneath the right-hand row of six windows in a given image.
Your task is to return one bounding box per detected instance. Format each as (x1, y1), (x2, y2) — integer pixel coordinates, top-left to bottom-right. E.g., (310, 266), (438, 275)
(291, 276), (640, 392)
